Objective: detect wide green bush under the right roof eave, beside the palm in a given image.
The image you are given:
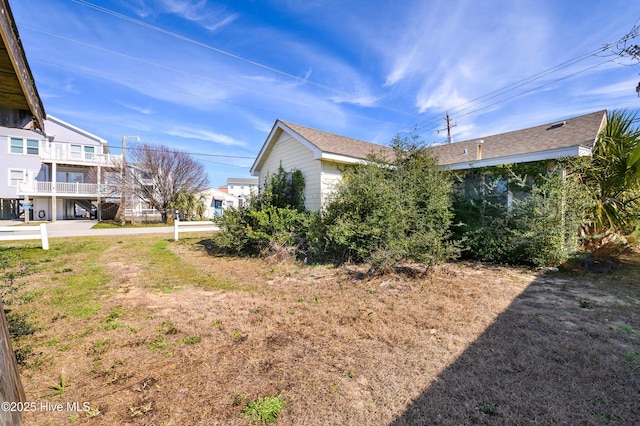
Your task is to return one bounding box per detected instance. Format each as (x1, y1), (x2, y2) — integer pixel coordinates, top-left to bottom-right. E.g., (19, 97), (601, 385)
(454, 162), (583, 266)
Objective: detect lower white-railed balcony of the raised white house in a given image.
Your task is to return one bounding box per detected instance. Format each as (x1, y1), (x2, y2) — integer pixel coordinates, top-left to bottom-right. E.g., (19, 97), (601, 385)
(17, 181), (120, 198)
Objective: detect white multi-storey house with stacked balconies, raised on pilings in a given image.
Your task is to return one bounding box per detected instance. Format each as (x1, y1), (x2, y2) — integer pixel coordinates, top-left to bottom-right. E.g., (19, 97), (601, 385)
(0, 116), (120, 221)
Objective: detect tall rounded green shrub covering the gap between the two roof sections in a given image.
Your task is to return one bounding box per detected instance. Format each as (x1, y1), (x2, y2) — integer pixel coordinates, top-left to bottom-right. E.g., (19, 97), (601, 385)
(323, 137), (457, 270)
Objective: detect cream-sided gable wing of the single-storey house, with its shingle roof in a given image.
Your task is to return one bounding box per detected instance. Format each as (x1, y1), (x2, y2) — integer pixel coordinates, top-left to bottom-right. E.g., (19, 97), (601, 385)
(251, 120), (390, 210)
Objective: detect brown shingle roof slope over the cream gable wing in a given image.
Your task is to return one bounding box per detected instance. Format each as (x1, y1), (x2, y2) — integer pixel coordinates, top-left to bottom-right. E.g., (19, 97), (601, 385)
(280, 120), (392, 159)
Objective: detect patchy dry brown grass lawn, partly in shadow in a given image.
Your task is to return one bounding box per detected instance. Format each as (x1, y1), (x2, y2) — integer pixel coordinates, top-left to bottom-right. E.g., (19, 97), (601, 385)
(0, 235), (640, 425)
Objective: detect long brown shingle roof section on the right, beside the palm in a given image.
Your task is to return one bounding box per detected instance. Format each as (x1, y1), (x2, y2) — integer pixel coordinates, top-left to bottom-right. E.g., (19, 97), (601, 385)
(430, 110), (607, 165)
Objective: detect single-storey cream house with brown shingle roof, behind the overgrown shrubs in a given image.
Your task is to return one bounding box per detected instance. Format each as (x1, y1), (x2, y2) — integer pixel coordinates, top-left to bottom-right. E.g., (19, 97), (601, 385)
(251, 110), (607, 210)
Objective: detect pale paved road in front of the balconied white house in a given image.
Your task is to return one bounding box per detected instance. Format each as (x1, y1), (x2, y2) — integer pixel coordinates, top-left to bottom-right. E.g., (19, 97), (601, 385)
(0, 219), (173, 238)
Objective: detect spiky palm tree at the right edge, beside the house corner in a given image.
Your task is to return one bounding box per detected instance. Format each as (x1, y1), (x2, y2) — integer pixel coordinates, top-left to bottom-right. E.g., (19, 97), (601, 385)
(573, 111), (640, 247)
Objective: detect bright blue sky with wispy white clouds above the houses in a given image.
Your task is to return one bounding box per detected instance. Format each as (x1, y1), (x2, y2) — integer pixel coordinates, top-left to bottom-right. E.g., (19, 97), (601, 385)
(10, 0), (640, 187)
